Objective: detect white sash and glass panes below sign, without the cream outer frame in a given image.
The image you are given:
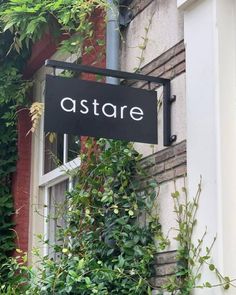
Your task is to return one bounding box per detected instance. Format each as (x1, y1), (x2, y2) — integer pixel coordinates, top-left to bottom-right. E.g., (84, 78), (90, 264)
(40, 134), (80, 259)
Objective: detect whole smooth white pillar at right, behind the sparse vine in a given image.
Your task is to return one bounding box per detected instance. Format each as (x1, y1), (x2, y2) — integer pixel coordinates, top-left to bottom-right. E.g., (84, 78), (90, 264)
(183, 0), (236, 295)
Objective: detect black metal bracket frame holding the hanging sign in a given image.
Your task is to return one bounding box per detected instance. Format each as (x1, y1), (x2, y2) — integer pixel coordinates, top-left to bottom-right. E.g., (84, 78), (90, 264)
(45, 60), (177, 146)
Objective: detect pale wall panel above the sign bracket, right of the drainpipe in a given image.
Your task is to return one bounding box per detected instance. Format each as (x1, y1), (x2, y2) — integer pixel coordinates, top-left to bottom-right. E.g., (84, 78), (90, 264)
(121, 0), (183, 72)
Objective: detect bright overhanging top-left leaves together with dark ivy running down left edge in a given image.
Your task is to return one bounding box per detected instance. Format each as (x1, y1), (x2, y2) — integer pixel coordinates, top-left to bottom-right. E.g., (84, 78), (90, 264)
(0, 0), (106, 281)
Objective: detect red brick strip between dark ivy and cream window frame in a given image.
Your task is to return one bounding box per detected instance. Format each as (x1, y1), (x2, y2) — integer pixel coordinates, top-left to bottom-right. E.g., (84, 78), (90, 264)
(12, 110), (31, 252)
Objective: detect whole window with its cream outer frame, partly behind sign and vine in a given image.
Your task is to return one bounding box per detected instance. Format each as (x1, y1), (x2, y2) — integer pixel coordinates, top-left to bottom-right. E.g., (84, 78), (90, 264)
(30, 58), (80, 259)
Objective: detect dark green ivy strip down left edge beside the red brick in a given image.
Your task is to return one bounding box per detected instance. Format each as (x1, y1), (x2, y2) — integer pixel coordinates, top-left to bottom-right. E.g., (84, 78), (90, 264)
(0, 67), (28, 270)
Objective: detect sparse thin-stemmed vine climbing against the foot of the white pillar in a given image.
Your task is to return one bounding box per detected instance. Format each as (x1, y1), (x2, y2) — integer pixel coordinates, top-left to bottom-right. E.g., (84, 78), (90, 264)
(163, 182), (236, 295)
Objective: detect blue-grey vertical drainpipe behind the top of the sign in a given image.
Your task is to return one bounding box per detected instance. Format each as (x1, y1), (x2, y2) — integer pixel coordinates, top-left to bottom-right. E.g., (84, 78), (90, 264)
(106, 0), (120, 84)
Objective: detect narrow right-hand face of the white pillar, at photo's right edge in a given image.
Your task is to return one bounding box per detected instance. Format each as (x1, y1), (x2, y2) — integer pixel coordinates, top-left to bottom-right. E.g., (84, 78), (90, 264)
(216, 0), (236, 295)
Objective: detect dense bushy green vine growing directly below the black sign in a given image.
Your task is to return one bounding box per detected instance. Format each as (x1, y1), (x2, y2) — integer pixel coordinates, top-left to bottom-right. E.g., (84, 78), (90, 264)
(1, 138), (168, 295)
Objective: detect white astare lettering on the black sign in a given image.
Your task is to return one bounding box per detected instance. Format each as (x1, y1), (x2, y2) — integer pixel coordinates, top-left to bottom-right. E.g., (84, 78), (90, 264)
(61, 97), (144, 121)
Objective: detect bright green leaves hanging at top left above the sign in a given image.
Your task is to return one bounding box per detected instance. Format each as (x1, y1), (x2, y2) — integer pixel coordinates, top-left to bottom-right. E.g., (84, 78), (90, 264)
(0, 0), (107, 53)
